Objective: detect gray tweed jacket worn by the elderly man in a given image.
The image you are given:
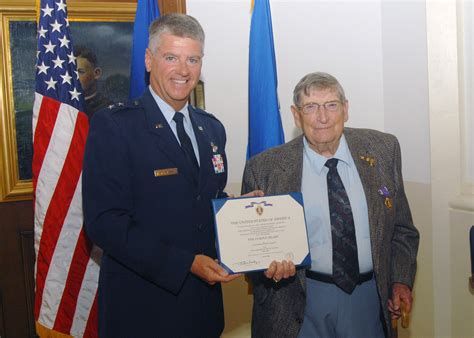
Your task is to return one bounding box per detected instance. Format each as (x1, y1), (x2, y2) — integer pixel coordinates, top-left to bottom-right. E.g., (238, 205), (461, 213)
(242, 128), (419, 338)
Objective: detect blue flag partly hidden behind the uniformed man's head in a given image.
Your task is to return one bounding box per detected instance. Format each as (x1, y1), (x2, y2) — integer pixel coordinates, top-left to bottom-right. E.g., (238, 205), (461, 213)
(129, 0), (160, 100)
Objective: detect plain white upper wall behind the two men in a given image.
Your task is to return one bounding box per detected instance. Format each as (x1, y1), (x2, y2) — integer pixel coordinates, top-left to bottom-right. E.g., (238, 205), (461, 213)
(187, 0), (430, 190)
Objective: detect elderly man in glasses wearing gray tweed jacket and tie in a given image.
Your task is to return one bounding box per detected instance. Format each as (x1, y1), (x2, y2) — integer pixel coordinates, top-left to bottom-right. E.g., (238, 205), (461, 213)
(242, 73), (419, 338)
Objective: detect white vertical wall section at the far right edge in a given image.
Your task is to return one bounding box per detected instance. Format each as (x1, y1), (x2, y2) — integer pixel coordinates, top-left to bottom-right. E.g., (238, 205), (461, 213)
(426, 1), (474, 337)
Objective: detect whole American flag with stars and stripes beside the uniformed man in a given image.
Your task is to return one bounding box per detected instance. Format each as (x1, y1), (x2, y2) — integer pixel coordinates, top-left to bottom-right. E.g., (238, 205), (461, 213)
(33, 0), (100, 337)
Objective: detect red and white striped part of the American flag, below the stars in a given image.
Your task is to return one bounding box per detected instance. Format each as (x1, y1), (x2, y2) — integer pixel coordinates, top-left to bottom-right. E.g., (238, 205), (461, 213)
(33, 93), (100, 337)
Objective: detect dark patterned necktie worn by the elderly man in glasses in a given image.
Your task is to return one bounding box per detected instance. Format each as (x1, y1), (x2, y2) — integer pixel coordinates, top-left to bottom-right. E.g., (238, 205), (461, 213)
(325, 158), (359, 294)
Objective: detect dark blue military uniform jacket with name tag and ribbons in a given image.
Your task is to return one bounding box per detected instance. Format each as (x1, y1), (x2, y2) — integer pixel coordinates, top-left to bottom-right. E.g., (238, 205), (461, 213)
(83, 89), (227, 338)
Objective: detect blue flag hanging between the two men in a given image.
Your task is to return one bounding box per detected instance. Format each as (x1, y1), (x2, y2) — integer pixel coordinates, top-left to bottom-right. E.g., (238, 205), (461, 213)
(247, 0), (285, 158)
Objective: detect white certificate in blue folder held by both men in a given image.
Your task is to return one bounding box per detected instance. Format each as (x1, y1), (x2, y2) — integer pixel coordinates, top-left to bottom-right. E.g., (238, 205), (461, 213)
(212, 192), (311, 273)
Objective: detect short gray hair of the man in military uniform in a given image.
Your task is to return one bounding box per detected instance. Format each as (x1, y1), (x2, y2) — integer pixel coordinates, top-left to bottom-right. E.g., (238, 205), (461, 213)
(148, 13), (205, 53)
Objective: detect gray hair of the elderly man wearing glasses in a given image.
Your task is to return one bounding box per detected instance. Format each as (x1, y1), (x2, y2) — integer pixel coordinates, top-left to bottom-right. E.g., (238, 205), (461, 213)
(293, 72), (346, 108)
